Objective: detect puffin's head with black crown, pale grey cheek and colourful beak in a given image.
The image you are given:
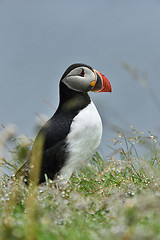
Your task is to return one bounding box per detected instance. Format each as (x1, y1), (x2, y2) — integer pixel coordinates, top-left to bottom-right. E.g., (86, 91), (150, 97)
(61, 63), (112, 92)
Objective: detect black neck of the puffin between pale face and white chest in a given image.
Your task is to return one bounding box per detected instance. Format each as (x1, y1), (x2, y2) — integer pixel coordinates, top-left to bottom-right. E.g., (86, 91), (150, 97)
(58, 82), (91, 112)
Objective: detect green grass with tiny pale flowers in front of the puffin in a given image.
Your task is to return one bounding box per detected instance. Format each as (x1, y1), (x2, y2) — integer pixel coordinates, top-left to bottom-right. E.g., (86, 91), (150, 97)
(0, 128), (160, 240)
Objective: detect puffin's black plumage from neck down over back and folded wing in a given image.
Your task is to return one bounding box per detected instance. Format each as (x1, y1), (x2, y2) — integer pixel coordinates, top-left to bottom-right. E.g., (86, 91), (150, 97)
(34, 82), (91, 183)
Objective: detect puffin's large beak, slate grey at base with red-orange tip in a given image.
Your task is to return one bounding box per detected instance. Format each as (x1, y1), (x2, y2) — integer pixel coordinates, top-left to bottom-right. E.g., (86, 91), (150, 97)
(91, 70), (112, 92)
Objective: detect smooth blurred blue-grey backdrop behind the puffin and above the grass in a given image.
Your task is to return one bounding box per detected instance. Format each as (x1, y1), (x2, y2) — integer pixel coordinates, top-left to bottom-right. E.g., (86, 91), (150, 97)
(0, 0), (160, 157)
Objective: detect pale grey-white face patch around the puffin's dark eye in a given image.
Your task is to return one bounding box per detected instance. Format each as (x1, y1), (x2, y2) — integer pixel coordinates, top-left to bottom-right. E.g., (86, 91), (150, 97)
(62, 66), (96, 92)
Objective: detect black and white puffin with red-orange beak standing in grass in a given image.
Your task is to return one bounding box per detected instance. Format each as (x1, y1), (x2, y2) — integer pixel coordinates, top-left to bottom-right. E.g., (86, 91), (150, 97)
(15, 63), (112, 185)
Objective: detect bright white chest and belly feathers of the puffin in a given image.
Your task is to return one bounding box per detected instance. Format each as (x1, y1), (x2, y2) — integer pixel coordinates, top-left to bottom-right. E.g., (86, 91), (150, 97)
(61, 102), (102, 180)
